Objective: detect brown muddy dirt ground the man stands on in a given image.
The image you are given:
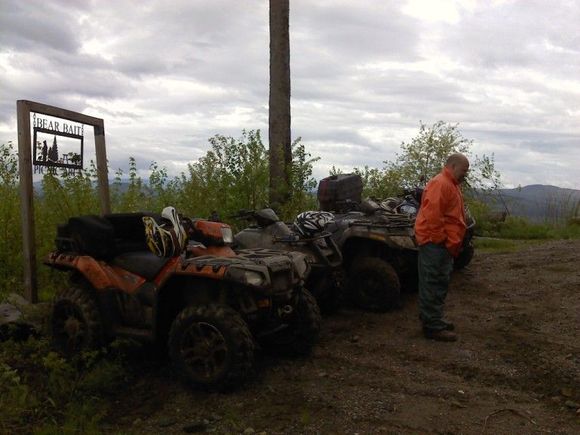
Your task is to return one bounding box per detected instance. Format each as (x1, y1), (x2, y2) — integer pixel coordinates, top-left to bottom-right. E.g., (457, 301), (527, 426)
(103, 241), (580, 434)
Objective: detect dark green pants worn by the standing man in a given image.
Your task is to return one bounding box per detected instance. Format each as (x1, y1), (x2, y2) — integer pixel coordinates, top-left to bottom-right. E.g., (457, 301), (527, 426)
(418, 243), (453, 331)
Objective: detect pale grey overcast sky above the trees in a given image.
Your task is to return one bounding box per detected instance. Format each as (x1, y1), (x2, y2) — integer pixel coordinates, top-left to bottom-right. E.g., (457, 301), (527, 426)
(0, 0), (580, 189)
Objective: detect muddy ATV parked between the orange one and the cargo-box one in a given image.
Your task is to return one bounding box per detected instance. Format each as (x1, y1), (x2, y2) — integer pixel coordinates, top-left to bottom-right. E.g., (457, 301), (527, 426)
(233, 208), (344, 313)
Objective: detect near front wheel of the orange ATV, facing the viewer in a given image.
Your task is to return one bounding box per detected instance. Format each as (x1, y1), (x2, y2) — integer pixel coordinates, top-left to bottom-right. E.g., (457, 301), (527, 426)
(168, 304), (254, 390)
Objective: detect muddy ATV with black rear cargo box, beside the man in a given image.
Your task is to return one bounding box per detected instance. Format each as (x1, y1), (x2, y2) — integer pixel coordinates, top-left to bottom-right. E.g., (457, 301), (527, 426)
(318, 174), (417, 312)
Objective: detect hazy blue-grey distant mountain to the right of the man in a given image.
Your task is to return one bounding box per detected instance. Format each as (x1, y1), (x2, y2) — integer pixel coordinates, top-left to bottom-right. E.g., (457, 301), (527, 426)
(477, 184), (580, 222)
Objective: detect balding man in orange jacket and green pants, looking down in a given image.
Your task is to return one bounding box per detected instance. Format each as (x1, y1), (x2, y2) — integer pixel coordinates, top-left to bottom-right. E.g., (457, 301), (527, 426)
(415, 153), (469, 341)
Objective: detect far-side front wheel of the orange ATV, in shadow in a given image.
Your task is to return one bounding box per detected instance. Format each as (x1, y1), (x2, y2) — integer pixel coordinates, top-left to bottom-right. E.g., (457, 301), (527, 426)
(262, 289), (321, 356)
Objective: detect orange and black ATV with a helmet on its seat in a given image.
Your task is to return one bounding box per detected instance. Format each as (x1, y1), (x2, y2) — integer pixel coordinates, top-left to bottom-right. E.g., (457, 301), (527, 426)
(45, 207), (320, 390)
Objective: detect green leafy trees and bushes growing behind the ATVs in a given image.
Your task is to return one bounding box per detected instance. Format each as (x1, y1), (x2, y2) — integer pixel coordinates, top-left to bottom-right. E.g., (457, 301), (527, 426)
(0, 121), (580, 300)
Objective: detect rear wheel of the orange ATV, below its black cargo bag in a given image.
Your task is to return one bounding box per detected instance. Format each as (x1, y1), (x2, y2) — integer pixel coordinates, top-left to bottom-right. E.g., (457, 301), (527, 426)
(51, 287), (102, 355)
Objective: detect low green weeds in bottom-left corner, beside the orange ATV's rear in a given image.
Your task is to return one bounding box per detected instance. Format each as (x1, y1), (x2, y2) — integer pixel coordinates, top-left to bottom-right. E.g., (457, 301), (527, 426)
(0, 338), (129, 434)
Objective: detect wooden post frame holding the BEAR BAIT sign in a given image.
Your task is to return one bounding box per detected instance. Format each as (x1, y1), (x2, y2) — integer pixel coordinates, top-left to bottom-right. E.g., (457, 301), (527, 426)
(16, 100), (111, 303)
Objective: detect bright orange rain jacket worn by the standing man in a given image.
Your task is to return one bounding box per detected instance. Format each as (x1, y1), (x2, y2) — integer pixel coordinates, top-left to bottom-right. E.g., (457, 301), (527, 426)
(415, 168), (467, 257)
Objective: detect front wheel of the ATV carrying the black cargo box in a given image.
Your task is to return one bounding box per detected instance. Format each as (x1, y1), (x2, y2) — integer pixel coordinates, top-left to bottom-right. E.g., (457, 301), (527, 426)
(348, 257), (401, 312)
